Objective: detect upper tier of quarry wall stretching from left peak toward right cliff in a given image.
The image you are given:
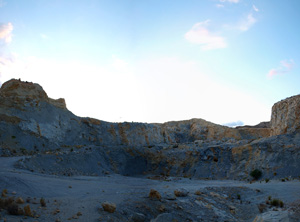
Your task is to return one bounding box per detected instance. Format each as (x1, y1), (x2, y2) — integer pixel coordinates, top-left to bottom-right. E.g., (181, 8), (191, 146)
(0, 79), (270, 152)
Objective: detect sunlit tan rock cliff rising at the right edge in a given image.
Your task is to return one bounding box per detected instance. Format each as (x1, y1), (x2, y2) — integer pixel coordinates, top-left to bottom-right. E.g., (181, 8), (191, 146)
(271, 95), (300, 136)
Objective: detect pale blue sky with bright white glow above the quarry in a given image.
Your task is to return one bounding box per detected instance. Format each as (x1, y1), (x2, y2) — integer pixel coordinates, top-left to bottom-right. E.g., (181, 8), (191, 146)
(0, 0), (300, 126)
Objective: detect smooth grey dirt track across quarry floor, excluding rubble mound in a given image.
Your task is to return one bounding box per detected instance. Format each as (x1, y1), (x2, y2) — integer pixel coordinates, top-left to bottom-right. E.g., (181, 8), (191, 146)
(0, 157), (300, 221)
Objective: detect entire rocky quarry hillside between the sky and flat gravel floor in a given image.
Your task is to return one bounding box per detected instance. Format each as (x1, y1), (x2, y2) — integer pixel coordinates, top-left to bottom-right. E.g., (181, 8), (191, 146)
(0, 79), (300, 179)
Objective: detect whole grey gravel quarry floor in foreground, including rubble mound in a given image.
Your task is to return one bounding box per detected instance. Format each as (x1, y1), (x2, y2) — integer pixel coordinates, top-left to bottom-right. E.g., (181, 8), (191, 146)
(0, 157), (300, 222)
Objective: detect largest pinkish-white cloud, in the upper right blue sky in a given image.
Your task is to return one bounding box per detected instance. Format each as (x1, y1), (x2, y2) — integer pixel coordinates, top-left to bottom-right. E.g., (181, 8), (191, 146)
(184, 20), (227, 50)
